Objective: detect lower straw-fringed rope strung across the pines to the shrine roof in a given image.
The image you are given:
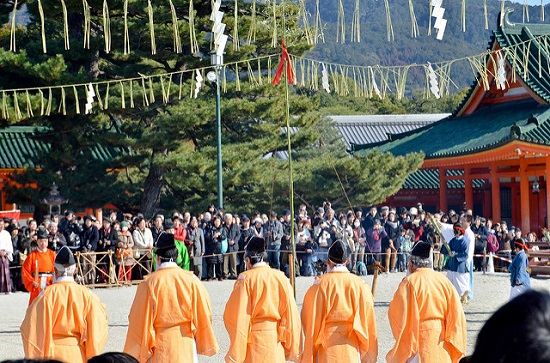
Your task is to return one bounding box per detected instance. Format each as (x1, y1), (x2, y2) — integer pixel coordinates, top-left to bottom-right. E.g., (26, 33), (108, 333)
(0, 29), (550, 120)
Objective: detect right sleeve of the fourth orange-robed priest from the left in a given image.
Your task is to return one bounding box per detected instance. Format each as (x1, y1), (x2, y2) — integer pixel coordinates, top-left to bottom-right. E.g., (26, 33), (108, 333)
(353, 283), (378, 363)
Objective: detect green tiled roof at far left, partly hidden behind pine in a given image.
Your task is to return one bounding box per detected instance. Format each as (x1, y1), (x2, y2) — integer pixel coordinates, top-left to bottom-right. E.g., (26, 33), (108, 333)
(0, 126), (120, 169)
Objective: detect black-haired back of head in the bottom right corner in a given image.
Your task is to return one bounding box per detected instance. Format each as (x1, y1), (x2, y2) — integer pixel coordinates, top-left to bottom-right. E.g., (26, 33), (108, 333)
(470, 290), (550, 363)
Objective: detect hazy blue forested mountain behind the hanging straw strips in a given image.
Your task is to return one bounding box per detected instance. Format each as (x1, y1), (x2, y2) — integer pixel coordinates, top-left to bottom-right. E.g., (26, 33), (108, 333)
(307, 0), (550, 92)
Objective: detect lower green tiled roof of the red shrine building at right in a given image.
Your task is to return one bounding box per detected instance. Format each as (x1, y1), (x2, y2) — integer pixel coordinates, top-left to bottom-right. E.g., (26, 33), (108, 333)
(355, 100), (550, 159)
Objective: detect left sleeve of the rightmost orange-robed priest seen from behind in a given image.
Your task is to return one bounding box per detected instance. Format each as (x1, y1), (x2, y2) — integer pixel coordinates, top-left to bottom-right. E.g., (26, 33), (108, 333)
(386, 278), (420, 363)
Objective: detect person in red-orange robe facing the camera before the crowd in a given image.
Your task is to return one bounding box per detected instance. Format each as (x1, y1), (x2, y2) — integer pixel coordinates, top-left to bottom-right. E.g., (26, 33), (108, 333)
(21, 227), (55, 306)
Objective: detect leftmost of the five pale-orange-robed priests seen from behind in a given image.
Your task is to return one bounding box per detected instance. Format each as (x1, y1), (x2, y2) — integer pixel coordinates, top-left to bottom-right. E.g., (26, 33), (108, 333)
(21, 246), (108, 363)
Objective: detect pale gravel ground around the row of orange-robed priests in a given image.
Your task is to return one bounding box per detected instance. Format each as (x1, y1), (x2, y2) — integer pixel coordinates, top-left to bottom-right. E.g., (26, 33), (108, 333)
(0, 273), (550, 363)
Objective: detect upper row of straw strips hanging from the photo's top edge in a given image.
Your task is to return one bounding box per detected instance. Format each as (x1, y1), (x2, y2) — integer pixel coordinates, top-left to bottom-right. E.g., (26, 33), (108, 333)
(9, 0), (545, 55)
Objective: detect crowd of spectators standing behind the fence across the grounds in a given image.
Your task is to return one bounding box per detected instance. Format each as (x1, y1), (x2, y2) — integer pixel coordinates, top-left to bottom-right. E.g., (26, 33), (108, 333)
(4, 202), (544, 291)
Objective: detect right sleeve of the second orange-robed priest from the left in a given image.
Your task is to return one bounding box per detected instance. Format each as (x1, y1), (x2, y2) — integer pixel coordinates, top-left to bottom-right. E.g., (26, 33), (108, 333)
(193, 279), (220, 356)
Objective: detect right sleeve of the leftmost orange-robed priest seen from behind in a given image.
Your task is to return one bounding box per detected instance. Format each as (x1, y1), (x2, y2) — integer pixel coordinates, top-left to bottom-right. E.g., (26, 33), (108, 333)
(85, 292), (109, 359)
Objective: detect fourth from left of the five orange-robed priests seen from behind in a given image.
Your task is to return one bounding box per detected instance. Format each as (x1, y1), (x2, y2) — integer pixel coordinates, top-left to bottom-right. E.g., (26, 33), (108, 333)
(302, 240), (378, 363)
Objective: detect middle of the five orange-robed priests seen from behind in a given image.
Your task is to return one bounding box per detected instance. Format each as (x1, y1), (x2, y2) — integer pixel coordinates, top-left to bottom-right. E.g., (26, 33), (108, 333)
(223, 237), (301, 363)
